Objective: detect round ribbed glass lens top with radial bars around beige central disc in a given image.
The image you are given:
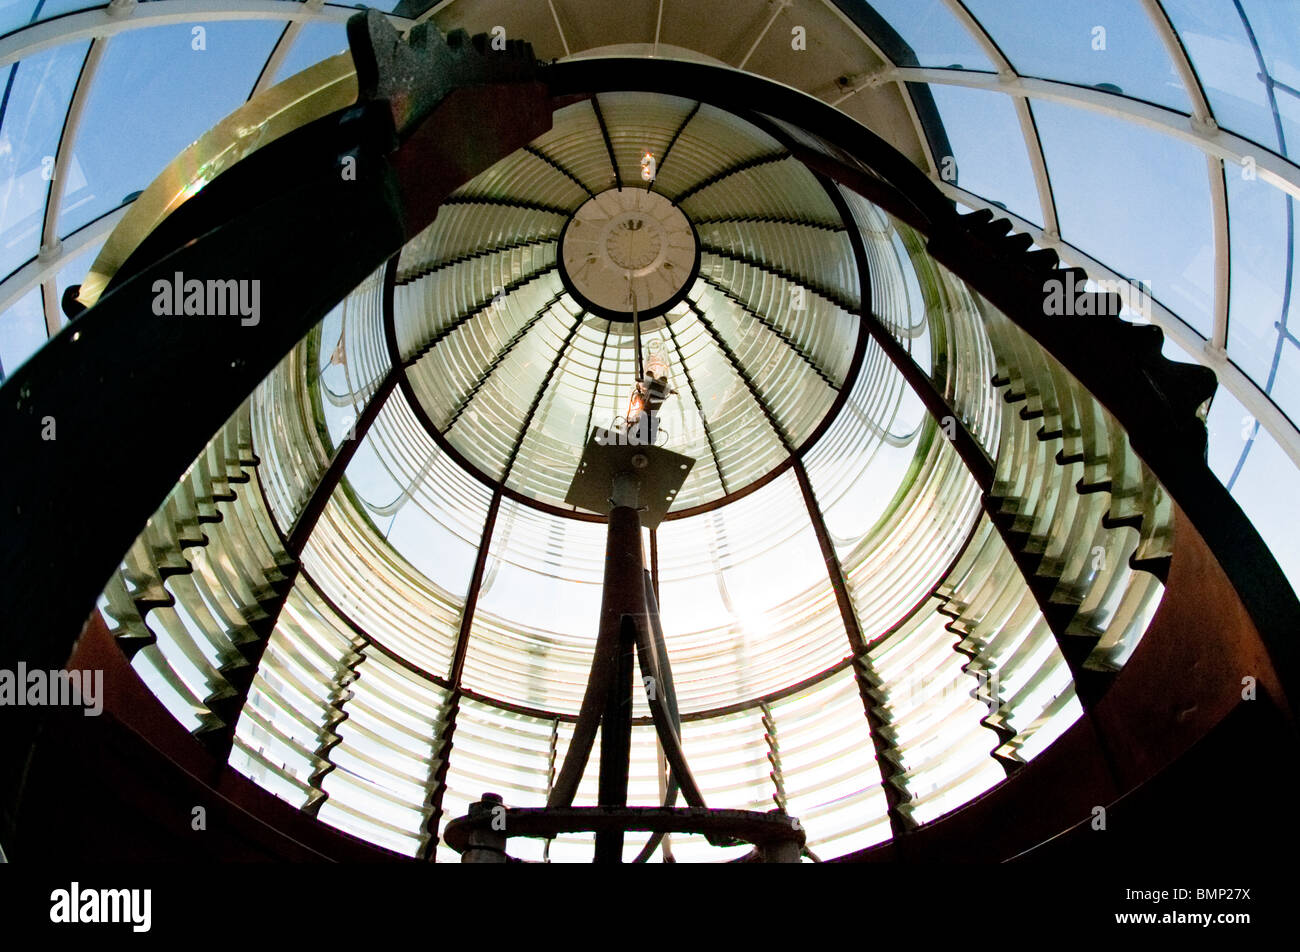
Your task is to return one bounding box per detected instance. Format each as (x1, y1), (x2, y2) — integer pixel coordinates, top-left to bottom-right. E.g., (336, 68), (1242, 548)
(394, 94), (861, 512)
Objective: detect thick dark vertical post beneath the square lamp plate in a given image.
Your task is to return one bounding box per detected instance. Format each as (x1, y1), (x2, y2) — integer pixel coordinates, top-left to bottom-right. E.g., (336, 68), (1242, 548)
(595, 472), (646, 862)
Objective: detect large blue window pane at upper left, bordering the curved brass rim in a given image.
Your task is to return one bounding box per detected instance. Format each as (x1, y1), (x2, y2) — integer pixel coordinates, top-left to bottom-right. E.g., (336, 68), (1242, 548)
(59, 21), (283, 237)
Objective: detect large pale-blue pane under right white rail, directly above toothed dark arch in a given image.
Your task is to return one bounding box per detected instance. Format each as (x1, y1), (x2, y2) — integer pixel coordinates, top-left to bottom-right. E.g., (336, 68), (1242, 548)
(1034, 103), (1214, 338)
